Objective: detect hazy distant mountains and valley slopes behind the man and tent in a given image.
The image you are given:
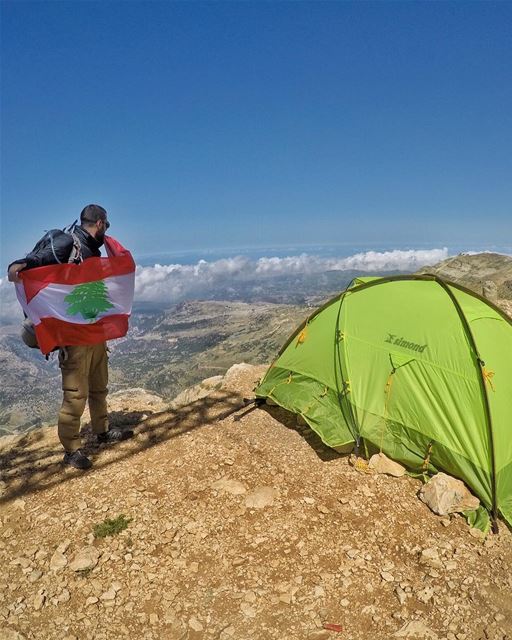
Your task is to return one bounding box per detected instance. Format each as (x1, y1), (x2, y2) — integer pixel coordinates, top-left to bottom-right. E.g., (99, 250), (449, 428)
(0, 253), (512, 435)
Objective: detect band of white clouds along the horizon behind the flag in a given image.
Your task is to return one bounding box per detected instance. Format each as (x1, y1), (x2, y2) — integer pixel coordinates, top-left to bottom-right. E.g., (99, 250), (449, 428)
(0, 248), (448, 322)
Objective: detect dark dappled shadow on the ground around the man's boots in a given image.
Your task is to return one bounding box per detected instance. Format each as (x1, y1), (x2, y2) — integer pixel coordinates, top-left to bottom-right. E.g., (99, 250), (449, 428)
(0, 391), (245, 504)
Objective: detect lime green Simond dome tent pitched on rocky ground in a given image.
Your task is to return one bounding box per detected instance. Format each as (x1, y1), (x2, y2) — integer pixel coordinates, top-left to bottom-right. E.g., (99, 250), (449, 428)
(256, 275), (512, 525)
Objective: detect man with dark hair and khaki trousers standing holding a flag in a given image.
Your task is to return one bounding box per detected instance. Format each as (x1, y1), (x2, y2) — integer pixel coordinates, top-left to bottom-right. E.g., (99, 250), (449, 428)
(8, 204), (133, 469)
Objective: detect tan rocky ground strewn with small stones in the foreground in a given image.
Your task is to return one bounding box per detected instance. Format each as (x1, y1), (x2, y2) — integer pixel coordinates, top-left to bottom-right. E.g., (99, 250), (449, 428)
(0, 365), (512, 640)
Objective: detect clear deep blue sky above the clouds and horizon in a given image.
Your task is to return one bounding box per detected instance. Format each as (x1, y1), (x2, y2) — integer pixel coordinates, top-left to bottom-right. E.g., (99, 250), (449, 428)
(1, 0), (512, 268)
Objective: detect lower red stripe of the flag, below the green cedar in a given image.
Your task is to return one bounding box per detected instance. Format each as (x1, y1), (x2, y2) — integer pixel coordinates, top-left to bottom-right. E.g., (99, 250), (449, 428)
(35, 316), (129, 354)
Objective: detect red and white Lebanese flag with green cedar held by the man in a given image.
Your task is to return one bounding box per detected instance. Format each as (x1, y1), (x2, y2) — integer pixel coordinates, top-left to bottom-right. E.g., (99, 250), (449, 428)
(16, 236), (135, 354)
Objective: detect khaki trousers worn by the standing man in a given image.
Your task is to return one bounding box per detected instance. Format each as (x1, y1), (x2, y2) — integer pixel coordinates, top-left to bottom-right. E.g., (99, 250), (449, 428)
(58, 342), (108, 453)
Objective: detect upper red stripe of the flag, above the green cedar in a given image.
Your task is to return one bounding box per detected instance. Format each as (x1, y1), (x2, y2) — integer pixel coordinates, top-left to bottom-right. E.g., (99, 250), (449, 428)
(20, 253), (135, 302)
